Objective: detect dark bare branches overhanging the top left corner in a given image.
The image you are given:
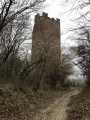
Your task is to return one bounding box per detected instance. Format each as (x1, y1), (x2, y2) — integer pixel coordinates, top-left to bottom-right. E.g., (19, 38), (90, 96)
(0, 0), (44, 33)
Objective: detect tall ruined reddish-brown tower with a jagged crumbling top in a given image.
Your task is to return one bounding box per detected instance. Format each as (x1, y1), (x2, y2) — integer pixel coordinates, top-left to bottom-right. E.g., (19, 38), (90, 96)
(31, 13), (61, 87)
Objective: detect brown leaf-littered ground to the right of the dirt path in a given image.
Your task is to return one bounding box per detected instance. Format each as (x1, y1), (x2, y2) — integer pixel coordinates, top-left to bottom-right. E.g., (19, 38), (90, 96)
(68, 88), (90, 120)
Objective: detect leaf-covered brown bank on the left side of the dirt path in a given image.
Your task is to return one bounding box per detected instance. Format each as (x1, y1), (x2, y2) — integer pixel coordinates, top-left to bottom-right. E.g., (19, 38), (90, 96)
(0, 84), (67, 120)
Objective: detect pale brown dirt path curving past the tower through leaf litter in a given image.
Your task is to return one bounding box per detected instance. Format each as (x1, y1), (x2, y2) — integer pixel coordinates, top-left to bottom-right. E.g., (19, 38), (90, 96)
(32, 90), (80, 120)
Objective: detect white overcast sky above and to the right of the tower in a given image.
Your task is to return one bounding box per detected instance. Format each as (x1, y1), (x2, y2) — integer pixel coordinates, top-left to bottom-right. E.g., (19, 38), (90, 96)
(41, 0), (82, 46)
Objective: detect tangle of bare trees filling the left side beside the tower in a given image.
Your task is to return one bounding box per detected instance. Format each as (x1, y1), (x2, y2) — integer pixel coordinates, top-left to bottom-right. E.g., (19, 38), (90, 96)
(0, 0), (44, 86)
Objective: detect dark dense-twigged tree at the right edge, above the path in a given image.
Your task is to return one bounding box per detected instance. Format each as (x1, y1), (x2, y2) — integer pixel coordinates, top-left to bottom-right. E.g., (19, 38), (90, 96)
(71, 28), (90, 86)
